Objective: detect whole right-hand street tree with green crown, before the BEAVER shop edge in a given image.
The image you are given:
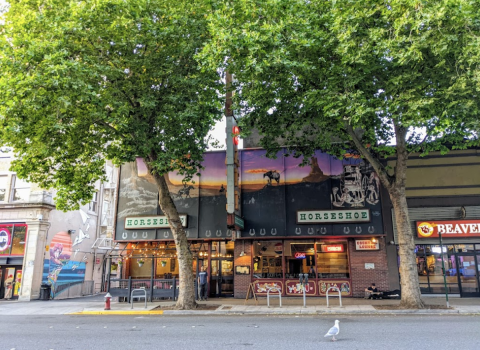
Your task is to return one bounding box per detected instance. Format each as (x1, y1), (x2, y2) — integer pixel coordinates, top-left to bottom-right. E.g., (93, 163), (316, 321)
(202, 0), (480, 308)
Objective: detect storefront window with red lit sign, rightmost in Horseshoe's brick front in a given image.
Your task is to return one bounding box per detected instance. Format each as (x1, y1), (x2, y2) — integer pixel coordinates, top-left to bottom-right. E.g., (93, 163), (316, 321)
(317, 241), (350, 278)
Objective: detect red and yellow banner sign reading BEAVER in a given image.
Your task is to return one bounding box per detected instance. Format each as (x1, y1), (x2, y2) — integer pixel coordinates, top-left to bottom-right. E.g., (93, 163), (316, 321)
(416, 220), (480, 238)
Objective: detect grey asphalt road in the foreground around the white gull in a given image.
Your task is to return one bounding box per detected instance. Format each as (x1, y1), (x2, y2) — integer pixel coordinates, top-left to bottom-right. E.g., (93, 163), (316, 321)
(0, 315), (480, 350)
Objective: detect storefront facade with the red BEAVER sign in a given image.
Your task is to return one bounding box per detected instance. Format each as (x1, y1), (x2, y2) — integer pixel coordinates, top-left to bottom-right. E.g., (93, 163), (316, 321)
(384, 149), (480, 297)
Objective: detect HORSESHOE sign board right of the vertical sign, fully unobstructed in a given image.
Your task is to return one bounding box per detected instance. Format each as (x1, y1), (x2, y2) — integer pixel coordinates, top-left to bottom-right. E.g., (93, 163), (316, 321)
(297, 209), (370, 224)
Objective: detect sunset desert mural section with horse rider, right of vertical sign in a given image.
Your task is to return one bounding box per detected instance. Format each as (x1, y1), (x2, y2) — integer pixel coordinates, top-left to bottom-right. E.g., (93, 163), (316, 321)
(241, 150), (383, 237)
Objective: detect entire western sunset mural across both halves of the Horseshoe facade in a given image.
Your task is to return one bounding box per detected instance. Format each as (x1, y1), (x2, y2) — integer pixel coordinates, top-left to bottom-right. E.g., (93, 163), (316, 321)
(116, 149), (383, 241)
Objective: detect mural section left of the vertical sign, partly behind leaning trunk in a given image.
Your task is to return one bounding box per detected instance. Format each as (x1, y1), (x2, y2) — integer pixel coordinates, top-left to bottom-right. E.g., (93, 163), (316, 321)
(116, 152), (228, 240)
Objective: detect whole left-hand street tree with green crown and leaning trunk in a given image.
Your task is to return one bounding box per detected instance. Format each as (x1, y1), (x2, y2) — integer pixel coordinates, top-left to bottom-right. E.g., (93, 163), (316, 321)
(0, 0), (221, 309)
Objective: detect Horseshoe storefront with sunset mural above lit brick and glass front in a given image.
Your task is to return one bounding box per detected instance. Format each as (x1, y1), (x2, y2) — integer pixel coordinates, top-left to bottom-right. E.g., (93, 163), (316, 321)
(115, 149), (389, 298)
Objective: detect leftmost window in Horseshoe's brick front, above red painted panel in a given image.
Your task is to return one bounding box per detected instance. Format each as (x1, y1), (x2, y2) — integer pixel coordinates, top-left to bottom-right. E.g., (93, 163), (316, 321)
(253, 241), (283, 278)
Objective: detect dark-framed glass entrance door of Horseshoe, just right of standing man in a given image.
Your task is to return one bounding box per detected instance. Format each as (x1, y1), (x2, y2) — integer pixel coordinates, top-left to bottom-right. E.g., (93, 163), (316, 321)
(210, 258), (233, 297)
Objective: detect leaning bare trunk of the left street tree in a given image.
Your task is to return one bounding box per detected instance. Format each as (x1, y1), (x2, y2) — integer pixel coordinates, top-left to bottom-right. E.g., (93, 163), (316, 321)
(146, 162), (197, 310)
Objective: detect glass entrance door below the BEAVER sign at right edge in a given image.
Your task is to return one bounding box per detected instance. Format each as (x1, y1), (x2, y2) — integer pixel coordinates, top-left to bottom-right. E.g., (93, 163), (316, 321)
(456, 253), (480, 298)
